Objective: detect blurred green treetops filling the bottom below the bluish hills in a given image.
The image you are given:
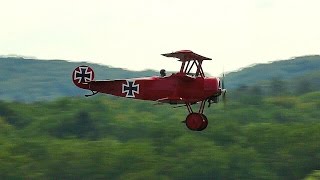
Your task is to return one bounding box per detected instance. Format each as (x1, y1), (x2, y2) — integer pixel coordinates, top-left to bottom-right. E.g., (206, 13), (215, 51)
(0, 92), (320, 179)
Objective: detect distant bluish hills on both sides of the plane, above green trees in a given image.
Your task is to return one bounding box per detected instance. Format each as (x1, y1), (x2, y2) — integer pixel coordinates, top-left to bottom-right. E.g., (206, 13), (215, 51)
(0, 55), (320, 102)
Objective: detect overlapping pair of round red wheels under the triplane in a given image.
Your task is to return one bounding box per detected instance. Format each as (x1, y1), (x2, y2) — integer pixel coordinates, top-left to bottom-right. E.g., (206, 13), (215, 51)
(186, 113), (208, 131)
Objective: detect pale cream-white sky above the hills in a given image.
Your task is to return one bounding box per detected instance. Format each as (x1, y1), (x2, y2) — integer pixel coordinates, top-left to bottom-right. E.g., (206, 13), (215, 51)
(0, 0), (320, 75)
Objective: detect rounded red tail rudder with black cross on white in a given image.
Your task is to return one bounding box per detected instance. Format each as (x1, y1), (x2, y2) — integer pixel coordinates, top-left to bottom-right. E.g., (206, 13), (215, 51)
(72, 66), (94, 89)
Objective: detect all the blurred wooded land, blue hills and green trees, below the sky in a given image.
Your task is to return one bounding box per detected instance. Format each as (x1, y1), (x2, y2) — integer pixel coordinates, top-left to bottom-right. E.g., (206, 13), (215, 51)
(0, 56), (320, 179)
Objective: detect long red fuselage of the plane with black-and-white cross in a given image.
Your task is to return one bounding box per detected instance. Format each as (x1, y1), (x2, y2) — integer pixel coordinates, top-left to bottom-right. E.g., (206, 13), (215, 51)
(79, 73), (219, 104)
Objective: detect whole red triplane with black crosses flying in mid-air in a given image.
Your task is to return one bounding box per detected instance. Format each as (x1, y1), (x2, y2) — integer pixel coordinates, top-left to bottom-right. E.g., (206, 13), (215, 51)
(72, 50), (226, 131)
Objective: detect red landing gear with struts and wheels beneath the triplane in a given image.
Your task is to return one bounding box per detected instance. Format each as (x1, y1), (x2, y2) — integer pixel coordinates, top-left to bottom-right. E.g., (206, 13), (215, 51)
(185, 101), (208, 131)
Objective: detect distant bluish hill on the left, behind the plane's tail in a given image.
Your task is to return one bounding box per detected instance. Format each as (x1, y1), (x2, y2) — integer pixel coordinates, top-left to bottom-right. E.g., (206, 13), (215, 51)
(0, 57), (158, 102)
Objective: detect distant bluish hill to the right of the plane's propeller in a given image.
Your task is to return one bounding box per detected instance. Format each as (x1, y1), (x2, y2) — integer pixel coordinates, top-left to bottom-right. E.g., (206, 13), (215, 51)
(226, 55), (320, 89)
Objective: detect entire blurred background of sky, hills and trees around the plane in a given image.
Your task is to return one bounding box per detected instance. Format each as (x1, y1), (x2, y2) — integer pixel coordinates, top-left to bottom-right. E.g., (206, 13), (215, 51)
(0, 0), (320, 180)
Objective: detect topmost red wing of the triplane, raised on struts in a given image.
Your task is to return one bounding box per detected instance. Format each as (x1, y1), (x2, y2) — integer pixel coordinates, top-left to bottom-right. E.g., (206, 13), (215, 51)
(162, 50), (212, 62)
